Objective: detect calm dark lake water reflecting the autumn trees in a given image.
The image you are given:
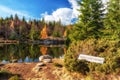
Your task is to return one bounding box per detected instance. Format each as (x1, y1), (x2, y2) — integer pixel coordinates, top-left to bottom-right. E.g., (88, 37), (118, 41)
(0, 44), (65, 63)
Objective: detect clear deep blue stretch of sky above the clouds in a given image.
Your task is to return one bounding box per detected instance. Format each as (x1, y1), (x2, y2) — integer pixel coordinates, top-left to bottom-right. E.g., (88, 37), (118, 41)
(0, 0), (71, 17)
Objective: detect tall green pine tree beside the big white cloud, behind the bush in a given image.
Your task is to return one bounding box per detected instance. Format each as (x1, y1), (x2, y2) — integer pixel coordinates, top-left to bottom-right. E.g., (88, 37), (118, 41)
(69, 0), (104, 40)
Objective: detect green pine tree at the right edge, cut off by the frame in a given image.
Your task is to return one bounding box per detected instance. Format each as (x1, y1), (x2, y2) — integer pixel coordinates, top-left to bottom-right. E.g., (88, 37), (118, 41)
(104, 0), (120, 39)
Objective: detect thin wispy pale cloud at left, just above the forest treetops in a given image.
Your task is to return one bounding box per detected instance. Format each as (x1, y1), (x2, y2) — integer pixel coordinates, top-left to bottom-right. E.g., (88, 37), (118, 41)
(0, 5), (33, 19)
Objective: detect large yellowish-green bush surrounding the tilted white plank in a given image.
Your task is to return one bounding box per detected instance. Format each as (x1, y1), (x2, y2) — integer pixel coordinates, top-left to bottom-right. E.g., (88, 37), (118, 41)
(64, 39), (120, 74)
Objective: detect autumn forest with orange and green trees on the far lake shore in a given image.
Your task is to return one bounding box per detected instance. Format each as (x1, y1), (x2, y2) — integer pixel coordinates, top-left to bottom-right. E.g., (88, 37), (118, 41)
(0, 14), (65, 40)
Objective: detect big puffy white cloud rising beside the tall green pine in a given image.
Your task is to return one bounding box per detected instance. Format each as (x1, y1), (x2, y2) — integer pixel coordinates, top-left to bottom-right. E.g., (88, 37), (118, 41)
(42, 0), (79, 25)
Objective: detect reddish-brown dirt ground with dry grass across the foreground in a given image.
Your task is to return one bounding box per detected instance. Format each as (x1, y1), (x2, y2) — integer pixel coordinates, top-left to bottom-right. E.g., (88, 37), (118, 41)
(0, 59), (120, 80)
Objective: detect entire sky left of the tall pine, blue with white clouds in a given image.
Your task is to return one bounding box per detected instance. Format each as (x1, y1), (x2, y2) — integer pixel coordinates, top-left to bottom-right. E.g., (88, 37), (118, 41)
(0, 0), (107, 24)
